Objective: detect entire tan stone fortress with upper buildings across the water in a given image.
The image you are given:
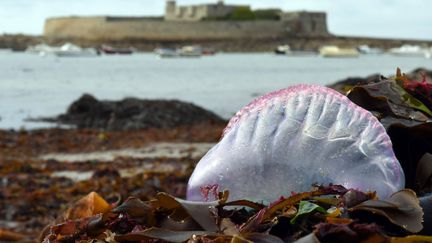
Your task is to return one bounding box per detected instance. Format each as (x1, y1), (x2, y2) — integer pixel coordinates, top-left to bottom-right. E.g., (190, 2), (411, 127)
(44, 0), (330, 42)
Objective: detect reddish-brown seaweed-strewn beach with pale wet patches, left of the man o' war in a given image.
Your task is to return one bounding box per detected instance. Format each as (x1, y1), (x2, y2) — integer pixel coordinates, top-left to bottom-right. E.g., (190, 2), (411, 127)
(0, 125), (223, 239)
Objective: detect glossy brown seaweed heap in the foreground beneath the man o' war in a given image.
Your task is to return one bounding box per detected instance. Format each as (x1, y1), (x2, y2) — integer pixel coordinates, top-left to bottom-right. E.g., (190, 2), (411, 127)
(41, 185), (429, 242)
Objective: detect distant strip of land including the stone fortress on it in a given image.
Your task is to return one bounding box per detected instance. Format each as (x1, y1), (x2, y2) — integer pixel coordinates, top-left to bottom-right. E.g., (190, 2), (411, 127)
(0, 1), (432, 52)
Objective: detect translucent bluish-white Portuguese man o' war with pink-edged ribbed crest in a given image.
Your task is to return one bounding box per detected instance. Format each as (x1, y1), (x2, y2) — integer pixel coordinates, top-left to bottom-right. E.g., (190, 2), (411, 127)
(187, 85), (405, 203)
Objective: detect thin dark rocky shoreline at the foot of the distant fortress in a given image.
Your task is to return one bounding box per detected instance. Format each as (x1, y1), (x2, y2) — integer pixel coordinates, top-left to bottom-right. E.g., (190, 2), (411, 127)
(0, 34), (432, 53)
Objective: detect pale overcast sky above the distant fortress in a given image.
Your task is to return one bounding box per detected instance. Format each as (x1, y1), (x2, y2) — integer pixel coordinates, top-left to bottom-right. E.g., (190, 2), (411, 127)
(0, 0), (432, 40)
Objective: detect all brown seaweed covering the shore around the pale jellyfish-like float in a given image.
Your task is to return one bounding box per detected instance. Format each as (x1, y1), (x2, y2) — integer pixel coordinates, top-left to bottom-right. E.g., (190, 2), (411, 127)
(0, 71), (432, 243)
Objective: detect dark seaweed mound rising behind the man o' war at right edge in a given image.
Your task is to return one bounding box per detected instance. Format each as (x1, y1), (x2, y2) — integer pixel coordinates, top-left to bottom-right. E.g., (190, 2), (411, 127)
(347, 69), (432, 194)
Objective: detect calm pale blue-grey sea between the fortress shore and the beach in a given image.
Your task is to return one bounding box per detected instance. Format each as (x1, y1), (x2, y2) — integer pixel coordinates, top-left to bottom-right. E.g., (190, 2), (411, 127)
(0, 51), (432, 129)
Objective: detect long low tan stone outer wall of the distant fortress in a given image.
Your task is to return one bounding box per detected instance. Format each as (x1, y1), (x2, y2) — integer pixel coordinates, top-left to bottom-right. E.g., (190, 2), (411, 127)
(44, 17), (288, 40)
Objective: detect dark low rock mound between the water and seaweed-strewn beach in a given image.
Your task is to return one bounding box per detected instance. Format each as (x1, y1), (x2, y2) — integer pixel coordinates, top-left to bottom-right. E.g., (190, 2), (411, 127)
(54, 94), (226, 130)
